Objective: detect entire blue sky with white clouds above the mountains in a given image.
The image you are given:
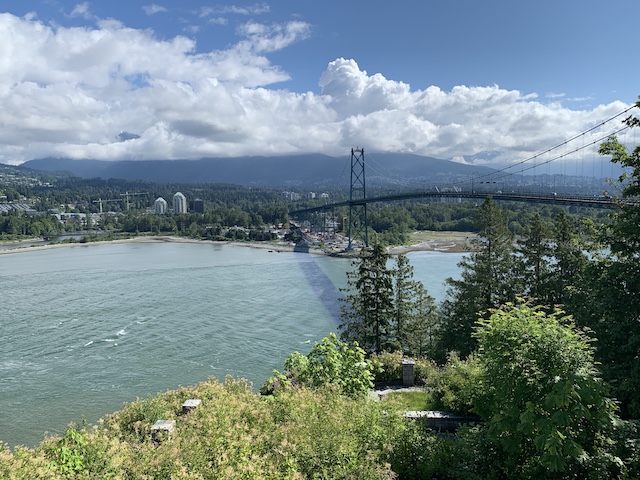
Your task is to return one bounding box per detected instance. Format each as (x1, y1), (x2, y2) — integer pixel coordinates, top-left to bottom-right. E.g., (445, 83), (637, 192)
(0, 0), (640, 171)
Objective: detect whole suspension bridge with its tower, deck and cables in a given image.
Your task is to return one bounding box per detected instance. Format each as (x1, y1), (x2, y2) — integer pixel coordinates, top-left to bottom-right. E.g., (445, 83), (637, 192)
(289, 105), (640, 250)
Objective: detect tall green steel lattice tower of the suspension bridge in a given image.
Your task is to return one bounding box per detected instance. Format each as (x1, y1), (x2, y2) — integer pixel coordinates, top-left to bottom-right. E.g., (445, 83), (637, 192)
(347, 148), (369, 251)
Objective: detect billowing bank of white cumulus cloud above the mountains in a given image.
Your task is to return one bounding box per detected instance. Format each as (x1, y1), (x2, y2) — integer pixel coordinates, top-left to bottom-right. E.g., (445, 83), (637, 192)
(0, 12), (626, 164)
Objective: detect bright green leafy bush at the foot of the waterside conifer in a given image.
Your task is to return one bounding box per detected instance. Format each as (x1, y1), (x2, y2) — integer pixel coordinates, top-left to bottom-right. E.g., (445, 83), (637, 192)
(261, 333), (379, 398)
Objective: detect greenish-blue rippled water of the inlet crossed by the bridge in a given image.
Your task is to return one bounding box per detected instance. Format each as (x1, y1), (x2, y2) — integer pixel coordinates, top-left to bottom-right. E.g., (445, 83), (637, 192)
(0, 243), (461, 446)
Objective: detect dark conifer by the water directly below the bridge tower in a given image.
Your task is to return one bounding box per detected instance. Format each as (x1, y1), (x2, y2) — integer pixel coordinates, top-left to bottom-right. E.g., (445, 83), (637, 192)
(339, 244), (394, 352)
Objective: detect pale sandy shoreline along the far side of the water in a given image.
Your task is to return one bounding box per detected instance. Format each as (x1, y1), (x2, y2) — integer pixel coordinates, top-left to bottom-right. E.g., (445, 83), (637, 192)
(0, 232), (473, 255)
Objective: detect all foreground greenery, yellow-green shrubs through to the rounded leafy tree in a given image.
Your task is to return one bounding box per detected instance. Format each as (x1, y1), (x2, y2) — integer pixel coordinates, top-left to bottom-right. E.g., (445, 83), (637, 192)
(0, 304), (640, 480)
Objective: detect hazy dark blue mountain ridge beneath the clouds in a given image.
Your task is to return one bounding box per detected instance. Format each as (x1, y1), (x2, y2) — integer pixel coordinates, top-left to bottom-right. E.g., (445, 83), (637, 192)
(21, 153), (494, 187)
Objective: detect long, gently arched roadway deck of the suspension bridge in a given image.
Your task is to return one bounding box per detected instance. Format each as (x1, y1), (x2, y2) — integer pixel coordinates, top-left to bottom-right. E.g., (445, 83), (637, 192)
(289, 192), (640, 215)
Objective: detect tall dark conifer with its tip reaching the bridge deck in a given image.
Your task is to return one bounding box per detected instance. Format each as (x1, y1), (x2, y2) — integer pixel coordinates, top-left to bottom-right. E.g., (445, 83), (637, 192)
(437, 198), (520, 360)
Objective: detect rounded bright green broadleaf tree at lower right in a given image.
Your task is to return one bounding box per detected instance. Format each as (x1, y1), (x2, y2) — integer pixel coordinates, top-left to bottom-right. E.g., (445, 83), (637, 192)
(474, 303), (620, 478)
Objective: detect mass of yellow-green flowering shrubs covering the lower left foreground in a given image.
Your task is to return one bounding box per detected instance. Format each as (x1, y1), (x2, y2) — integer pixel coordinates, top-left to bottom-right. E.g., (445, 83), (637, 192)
(0, 379), (406, 480)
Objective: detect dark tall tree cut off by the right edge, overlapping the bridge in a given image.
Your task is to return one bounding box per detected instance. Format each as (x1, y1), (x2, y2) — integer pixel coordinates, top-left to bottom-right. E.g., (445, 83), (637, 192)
(571, 101), (640, 418)
